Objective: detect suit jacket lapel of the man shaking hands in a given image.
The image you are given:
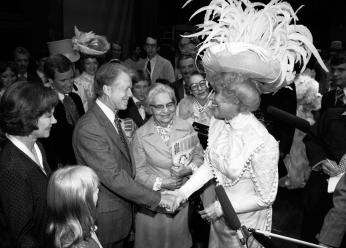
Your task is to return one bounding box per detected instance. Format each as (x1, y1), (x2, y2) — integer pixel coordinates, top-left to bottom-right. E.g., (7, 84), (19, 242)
(91, 104), (131, 163)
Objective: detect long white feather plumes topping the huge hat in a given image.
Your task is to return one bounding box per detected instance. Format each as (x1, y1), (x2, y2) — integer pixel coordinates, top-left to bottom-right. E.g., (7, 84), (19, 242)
(184, 0), (328, 91)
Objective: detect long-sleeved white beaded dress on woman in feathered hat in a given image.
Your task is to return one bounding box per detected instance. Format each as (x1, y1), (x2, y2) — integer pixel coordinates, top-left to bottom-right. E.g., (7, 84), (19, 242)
(180, 113), (279, 248)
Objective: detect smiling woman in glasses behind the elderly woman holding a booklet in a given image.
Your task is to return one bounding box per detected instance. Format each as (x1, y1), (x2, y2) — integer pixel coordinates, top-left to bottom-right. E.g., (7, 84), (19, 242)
(177, 71), (213, 126)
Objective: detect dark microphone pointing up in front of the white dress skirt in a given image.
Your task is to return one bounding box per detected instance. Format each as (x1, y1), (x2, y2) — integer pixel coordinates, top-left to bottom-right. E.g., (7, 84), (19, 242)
(215, 185), (246, 245)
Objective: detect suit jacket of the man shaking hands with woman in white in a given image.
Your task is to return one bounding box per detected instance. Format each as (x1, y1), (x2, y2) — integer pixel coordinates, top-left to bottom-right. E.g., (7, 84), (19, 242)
(73, 104), (160, 244)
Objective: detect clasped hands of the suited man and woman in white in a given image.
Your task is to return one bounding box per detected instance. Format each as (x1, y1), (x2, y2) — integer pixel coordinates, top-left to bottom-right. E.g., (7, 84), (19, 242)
(159, 190), (187, 213)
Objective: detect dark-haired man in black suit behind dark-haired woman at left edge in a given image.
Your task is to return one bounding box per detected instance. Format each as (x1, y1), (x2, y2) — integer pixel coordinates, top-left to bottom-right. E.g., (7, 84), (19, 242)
(41, 54), (84, 170)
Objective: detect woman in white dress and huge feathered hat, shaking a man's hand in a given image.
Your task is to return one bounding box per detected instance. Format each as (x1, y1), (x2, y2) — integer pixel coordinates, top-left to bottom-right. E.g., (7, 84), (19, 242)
(165, 0), (325, 248)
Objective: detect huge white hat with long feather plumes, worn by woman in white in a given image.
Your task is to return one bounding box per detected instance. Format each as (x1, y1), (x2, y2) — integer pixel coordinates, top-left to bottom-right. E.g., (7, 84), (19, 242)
(184, 0), (328, 93)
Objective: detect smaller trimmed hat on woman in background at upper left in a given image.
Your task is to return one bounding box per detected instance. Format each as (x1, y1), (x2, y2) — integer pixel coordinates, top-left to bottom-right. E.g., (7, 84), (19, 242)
(72, 26), (110, 55)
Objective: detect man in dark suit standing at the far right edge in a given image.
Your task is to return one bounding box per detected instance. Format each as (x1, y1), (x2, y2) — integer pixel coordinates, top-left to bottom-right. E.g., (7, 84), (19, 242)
(302, 52), (346, 242)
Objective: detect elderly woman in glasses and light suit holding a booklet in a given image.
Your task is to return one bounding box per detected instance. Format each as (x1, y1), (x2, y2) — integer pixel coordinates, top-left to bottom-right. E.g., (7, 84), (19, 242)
(132, 84), (203, 248)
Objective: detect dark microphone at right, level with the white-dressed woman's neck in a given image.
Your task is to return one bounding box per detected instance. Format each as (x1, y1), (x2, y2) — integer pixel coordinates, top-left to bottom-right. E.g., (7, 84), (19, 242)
(266, 105), (311, 133)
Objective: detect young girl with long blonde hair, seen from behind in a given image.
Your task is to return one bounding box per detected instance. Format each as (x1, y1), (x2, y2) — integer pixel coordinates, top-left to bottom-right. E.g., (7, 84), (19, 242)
(47, 165), (102, 248)
